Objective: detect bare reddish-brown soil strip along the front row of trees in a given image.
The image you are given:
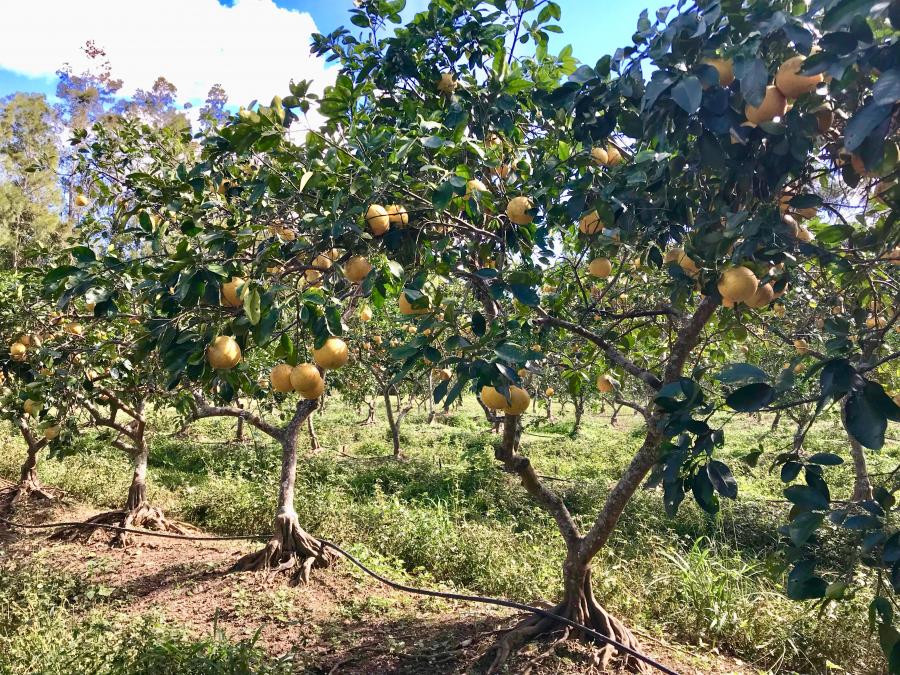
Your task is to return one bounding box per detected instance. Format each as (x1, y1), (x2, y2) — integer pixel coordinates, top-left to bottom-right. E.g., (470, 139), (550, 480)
(0, 500), (756, 675)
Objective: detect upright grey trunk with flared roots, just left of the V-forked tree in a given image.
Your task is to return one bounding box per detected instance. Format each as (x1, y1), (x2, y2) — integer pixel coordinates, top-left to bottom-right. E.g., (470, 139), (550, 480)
(231, 400), (335, 583)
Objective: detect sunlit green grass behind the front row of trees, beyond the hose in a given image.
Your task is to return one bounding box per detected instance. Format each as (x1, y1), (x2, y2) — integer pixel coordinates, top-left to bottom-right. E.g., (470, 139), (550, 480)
(0, 400), (900, 672)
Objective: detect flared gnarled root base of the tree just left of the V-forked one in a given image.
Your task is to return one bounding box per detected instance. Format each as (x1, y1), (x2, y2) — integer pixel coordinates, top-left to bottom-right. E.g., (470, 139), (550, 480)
(230, 512), (335, 585)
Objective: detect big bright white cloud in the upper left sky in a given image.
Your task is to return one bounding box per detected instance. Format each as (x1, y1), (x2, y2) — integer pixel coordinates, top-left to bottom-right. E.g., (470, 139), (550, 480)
(0, 0), (335, 123)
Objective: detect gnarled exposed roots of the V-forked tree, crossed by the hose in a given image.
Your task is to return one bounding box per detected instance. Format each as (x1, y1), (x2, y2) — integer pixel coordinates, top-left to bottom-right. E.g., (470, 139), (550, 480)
(487, 590), (651, 674)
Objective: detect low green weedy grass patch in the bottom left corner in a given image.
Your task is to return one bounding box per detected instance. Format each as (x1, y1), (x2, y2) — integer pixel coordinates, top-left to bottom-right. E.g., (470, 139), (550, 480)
(0, 554), (292, 675)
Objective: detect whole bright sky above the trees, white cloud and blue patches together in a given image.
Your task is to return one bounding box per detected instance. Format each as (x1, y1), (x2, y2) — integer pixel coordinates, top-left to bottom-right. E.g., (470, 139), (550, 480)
(0, 0), (663, 105)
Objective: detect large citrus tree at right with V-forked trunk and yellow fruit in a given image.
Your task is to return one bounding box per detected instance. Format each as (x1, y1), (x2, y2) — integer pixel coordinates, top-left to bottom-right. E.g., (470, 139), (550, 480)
(298, 0), (898, 668)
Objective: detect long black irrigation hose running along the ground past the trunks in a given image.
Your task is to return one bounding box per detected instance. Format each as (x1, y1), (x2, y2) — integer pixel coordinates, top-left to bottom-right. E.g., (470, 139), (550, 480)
(0, 518), (678, 675)
